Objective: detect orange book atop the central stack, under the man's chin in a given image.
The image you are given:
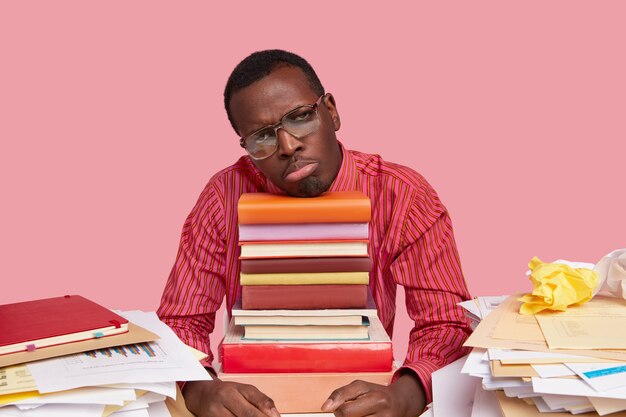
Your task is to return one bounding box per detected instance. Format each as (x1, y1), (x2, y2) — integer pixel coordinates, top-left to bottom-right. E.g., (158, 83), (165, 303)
(238, 191), (372, 224)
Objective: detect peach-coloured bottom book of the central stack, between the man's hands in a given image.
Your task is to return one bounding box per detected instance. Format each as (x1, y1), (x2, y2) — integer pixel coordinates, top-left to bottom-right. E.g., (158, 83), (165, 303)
(217, 368), (395, 413)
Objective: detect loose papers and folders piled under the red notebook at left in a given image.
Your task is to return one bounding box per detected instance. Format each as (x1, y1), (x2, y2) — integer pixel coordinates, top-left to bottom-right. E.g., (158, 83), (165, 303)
(0, 311), (210, 417)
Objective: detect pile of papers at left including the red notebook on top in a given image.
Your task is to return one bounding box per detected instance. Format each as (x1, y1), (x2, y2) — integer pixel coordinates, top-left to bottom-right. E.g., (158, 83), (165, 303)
(0, 295), (210, 417)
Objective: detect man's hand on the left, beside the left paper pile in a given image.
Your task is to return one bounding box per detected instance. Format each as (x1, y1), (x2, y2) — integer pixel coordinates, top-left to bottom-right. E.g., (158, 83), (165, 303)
(183, 379), (280, 417)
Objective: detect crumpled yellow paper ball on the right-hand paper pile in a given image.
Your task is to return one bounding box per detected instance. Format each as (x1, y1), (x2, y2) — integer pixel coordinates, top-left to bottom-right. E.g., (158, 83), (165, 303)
(519, 256), (598, 315)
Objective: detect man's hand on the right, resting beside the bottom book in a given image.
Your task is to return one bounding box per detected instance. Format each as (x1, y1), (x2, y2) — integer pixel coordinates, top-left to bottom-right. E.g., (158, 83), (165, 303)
(322, 373), (426, 417)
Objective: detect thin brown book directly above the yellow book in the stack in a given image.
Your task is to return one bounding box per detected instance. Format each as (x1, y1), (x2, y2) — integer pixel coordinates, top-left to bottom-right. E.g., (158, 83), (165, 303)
(241, 257), (372, 274)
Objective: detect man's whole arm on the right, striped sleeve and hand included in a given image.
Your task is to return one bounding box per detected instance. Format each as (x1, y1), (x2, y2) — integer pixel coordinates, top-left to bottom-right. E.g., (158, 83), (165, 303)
(323, 186), (471, 417)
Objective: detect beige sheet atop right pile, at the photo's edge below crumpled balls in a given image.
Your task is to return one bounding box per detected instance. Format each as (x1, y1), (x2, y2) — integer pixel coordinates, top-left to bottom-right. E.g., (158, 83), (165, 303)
(536, 296), (626, 349)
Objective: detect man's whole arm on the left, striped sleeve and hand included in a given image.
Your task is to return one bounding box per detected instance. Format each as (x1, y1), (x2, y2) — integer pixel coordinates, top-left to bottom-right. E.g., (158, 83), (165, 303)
(157, 183), (278, 417)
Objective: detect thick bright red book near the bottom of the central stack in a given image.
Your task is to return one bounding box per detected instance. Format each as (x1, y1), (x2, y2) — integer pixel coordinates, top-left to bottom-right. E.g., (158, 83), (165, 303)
(219, 317), (393, 373)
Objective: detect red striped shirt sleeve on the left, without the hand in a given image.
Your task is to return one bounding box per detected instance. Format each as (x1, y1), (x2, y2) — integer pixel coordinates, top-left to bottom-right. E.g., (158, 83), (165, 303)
(157, 183), (226, 368)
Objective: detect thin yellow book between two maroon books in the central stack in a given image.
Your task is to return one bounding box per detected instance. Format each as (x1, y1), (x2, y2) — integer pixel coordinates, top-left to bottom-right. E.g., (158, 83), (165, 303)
(240, 272), (369, 285)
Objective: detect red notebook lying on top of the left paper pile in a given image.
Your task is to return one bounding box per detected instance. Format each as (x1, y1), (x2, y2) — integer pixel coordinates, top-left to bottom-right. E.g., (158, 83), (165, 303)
(0, 295), (128, 354)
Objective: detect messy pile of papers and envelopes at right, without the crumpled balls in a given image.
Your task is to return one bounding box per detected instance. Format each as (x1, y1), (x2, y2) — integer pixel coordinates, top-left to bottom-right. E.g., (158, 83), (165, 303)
(448, 295), (626, 417)
